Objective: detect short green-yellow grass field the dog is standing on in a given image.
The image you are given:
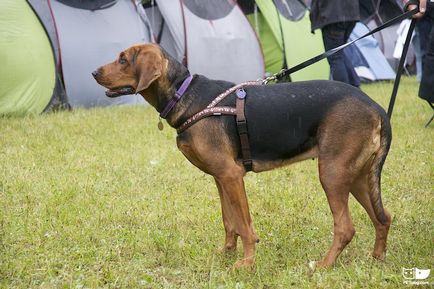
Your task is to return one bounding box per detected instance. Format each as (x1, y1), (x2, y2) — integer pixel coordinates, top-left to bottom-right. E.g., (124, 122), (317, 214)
(0, 78), (434, 288)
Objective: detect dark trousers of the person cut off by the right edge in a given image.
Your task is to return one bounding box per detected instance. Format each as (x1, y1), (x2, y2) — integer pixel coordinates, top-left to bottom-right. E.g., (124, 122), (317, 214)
(418, 13), (434, 103)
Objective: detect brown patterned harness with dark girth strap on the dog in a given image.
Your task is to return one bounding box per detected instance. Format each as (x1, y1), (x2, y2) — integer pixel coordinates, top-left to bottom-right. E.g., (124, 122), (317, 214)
(176, 81), (261, 172)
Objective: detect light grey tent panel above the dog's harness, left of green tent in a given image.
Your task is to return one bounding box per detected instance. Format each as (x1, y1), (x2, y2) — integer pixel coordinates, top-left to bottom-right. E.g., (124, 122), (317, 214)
(182, 0), (265, 83)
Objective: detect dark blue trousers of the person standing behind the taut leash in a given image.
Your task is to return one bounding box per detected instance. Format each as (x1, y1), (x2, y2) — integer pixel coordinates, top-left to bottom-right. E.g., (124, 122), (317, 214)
(321, 21), (360, 87)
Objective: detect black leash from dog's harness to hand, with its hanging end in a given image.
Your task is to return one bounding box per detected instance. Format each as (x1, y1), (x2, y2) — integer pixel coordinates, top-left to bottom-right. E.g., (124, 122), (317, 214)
(262, 7), (419, 119)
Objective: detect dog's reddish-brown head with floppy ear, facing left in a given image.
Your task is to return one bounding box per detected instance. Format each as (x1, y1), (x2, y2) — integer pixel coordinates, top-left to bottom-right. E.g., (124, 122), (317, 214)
(92, 44), (168, 97)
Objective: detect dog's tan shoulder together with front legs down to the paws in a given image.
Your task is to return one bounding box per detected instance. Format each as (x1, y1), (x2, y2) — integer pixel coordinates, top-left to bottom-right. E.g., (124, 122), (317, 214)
(178, 120), (258, 267)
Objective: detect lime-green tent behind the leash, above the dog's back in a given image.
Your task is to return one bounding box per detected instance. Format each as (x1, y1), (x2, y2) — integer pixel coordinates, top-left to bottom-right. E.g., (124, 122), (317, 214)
(239, 0), (329, 81)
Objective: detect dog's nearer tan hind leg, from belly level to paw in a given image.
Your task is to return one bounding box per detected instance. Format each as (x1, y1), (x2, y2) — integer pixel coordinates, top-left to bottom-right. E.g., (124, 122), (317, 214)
(317, 158), (355, 268)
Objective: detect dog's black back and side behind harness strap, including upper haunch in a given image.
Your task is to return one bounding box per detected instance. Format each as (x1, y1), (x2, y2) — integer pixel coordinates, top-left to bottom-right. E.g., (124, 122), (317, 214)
(245, 81), (390, 166)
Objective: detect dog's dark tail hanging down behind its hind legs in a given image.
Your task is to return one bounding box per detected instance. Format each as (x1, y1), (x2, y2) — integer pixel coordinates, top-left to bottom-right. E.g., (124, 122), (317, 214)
(369, 115), (392, 225)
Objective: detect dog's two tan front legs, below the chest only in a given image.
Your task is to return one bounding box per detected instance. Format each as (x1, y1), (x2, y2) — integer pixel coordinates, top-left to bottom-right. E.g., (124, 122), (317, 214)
(215, 165), (258, 268)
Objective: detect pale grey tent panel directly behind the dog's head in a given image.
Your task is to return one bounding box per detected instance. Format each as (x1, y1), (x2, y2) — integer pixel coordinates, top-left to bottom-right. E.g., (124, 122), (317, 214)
(49, 0), (151, 107)
